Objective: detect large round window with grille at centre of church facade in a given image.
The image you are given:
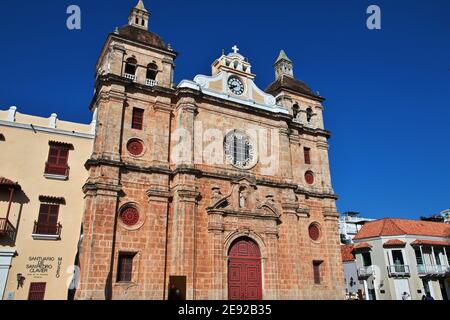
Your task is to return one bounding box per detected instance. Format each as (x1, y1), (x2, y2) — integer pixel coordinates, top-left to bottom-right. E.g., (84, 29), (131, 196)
(224, 130), (257, 169)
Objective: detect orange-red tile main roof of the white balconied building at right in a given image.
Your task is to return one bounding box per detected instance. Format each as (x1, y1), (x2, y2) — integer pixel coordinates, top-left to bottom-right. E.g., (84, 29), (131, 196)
(355, 218), (450, 240)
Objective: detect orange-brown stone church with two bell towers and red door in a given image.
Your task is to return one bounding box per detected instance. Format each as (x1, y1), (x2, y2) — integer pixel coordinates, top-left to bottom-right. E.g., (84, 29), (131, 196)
(75, 1), (344, 300)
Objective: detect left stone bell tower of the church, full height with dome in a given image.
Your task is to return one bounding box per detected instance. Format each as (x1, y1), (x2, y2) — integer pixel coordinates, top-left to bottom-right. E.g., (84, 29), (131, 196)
(76, 0), (177, 300)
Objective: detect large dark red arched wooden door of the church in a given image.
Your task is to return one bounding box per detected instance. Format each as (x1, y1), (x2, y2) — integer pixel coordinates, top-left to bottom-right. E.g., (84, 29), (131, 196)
(228, 238), (262, 300)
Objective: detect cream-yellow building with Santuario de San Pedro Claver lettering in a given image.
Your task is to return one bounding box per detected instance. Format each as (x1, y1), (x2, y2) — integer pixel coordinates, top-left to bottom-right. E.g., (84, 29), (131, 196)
(0, 107), (95, 300)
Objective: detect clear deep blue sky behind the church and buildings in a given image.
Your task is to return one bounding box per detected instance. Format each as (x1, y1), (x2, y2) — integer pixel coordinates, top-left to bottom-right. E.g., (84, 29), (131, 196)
(0, 0), (450, 218)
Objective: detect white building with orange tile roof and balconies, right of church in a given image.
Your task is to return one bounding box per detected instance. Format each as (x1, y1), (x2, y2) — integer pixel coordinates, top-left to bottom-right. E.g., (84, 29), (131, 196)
(353, 219), (450, 300)
